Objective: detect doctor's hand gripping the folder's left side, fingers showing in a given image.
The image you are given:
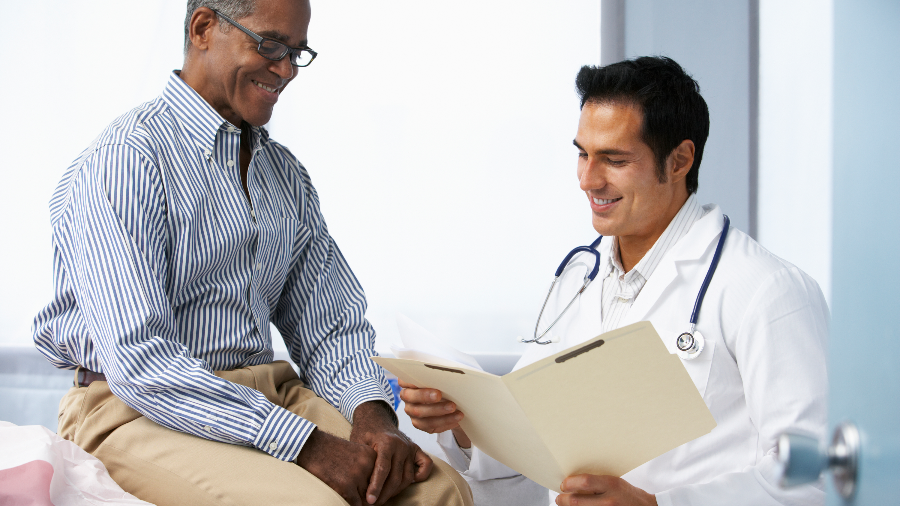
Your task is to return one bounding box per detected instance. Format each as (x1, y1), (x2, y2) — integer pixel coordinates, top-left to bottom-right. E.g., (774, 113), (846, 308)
(397, 380), (472, 448)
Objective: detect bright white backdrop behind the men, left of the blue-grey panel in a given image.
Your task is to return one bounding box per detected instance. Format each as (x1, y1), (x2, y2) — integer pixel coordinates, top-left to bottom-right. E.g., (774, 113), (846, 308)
(0, 0), (599, 351)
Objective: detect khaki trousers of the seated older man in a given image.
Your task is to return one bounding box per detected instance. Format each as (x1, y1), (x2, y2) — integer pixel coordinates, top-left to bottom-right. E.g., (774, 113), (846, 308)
(59, 362), (472, 506)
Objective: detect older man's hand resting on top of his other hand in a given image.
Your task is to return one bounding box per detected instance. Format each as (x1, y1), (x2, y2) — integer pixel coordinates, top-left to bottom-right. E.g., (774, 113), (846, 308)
(350, 401), (433, 506)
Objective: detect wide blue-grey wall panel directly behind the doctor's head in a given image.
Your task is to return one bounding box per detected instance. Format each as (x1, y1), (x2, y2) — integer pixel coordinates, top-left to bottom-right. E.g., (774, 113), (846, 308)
(624, 0), (752, 233)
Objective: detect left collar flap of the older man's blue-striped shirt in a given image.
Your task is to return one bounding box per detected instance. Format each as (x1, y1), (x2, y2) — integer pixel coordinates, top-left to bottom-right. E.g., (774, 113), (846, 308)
(162, 70), (237, 153)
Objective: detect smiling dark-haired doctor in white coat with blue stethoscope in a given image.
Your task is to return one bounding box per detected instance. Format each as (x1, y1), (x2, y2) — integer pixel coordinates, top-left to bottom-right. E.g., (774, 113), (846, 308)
(401, 57), (829, 506)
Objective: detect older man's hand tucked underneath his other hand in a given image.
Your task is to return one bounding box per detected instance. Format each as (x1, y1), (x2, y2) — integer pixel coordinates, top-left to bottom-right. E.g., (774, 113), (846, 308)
(297, 429), (376, 506)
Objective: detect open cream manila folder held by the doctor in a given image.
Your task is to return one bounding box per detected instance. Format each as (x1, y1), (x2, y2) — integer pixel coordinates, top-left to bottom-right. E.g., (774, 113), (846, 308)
(373, 322), (716, 492)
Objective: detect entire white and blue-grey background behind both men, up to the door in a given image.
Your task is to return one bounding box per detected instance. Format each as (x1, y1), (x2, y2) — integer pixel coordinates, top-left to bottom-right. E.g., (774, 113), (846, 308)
(0, 0), (833, 353)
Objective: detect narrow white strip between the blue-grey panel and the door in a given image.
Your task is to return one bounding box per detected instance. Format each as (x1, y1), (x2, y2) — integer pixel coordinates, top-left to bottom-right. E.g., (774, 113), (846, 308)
(758, 0), (836, 302)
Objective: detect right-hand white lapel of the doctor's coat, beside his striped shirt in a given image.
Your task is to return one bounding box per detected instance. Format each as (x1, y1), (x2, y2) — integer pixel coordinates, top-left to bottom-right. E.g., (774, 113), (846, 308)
(620, 206), (725, 327)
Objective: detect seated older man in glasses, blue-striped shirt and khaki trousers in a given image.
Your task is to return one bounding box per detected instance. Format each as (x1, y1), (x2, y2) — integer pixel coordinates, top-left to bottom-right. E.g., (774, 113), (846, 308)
(34, 0), (471, 505)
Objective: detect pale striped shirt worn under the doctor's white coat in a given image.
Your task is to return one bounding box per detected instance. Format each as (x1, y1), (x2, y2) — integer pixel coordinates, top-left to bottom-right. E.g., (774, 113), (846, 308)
(600, 194), (703, 332)
